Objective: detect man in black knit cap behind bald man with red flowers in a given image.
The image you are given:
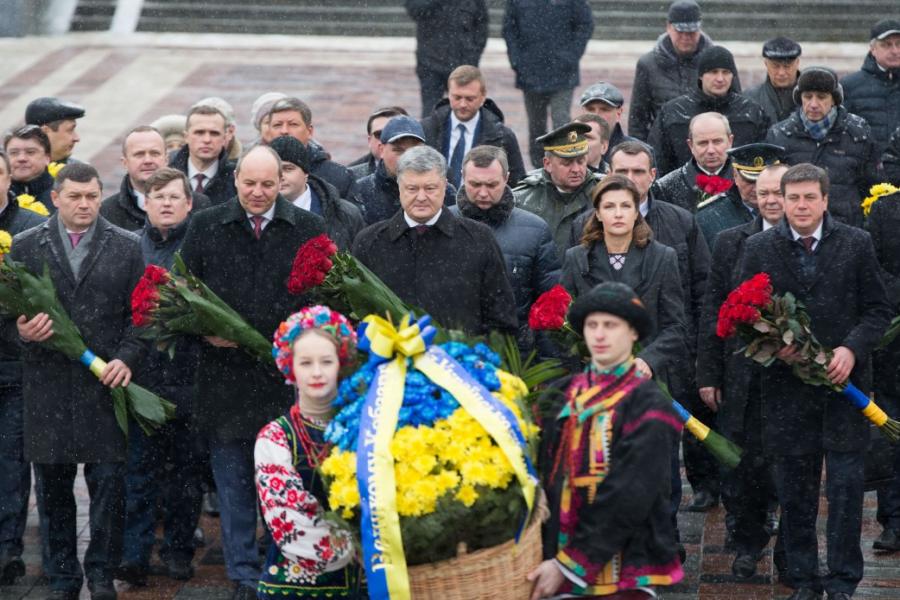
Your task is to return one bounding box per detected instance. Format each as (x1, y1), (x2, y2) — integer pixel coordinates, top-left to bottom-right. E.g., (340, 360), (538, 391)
(647, 46), (769, 175)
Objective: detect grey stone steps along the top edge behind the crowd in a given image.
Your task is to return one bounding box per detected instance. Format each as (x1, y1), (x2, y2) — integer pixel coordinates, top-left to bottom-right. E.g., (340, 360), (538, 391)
(72, 0), (900, 42)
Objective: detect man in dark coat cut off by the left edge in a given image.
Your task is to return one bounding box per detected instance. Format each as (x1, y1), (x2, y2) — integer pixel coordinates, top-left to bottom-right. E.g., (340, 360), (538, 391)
(0, 153), (47, 585)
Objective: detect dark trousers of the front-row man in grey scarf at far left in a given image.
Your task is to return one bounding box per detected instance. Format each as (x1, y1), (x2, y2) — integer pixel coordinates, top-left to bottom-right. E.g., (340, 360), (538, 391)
(34, 462), (125, 591)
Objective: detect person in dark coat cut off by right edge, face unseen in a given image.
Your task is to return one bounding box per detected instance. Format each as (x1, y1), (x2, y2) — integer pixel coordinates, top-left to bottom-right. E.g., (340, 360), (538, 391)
(866, 192), (900, 551)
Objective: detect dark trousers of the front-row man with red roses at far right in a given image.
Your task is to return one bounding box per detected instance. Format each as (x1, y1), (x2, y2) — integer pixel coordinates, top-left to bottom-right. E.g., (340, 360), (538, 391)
(775, 450), (865, 595)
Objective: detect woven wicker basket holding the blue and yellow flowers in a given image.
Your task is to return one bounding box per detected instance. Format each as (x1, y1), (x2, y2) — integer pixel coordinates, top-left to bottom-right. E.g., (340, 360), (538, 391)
(409, 493), (548, 600)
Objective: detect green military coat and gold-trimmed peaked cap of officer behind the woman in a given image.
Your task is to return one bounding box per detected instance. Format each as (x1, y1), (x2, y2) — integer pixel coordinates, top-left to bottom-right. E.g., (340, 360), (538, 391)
(513, 123), (603, 258)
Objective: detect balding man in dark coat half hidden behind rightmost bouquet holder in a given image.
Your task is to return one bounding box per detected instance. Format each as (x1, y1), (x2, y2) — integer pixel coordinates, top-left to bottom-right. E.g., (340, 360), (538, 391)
(697, 164), (787, 579)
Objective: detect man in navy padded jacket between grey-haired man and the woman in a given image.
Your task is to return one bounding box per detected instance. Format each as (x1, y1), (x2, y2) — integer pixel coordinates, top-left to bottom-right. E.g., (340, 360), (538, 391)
(451, 146), (560, 350)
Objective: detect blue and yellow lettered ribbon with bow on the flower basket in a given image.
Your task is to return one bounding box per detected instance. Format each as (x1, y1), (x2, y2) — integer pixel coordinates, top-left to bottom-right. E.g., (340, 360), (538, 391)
(356, 315), (537, 600)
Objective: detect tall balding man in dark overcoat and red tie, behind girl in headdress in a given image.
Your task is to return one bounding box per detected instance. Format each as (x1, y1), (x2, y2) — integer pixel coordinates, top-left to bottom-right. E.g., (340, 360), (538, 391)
(181, 146), (325, 600)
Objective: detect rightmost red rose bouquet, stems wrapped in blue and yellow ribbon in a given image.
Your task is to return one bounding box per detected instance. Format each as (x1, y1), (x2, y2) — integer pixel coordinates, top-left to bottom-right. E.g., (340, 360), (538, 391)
(716, 273), (900, 441)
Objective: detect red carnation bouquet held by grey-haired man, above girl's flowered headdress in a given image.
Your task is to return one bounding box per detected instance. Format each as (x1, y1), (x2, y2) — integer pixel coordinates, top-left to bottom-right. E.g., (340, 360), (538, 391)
(288, 234), (414, 323)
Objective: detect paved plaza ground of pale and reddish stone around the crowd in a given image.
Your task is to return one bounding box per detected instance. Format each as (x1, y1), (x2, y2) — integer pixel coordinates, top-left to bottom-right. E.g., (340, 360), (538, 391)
(0, 34), (900, 600)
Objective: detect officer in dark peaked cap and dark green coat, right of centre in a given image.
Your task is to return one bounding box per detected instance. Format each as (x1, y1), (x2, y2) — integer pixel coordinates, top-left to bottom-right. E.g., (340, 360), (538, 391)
(697, 143), (784, 250)
